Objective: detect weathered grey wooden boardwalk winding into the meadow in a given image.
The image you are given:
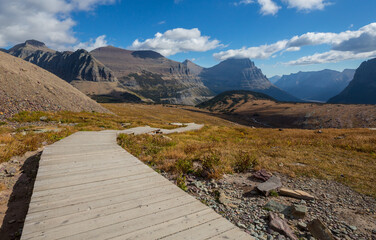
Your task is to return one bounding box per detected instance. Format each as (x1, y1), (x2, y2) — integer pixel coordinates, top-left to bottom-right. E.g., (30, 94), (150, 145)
(21, 124), (253, 240)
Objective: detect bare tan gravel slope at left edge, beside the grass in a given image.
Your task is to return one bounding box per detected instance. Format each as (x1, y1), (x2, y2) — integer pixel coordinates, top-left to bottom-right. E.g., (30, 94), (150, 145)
(0, 52), (109, 118)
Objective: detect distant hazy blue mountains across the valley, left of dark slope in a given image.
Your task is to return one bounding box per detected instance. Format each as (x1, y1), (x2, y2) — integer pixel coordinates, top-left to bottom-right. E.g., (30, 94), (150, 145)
(275, 69), (355, 102)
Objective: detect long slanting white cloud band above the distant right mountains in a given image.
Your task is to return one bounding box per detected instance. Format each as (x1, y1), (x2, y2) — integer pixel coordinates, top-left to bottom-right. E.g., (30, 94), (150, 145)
(214, 23), (376, 65)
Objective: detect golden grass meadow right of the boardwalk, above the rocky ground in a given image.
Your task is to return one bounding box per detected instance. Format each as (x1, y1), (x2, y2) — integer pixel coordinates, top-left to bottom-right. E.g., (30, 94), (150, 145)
(119, 125), (376, 197)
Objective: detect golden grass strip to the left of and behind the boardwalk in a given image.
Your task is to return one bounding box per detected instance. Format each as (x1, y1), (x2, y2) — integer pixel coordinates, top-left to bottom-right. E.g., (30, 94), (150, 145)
(0, 104), (230, 163)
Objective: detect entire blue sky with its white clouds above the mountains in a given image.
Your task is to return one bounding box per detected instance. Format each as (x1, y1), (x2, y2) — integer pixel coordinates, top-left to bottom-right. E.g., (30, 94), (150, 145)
(0, 0), (376, 77)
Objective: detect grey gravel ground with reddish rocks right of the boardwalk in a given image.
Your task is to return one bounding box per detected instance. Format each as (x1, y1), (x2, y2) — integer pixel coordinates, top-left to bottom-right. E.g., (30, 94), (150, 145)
(164, 173), (376, 240)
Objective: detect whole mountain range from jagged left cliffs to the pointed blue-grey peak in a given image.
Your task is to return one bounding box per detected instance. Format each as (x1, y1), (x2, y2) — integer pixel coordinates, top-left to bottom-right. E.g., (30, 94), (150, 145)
(3, 40), (299, 105)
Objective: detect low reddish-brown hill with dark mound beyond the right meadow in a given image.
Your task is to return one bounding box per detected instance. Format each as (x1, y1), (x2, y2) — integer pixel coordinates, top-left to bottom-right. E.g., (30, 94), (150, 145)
(198, 91), (376, 129)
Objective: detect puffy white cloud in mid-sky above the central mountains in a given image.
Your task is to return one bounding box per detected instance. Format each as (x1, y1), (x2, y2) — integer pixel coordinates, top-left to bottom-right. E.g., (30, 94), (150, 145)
(130, 28), (223, 56)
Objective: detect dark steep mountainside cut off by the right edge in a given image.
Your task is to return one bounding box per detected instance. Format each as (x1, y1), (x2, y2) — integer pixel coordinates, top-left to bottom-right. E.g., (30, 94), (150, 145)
(328, 58), (376, 104)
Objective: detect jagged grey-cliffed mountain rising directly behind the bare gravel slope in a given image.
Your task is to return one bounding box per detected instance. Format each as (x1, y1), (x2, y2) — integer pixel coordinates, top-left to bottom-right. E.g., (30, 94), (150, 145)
(6, 40), (140, 102)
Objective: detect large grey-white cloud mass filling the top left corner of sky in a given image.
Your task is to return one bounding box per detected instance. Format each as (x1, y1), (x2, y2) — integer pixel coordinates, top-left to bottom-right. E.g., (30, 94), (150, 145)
(0, 0), (116, 50)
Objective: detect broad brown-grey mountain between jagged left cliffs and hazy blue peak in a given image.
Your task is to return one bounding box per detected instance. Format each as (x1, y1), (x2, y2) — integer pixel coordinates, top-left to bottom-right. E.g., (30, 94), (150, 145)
(91, 46), (212, 105)
